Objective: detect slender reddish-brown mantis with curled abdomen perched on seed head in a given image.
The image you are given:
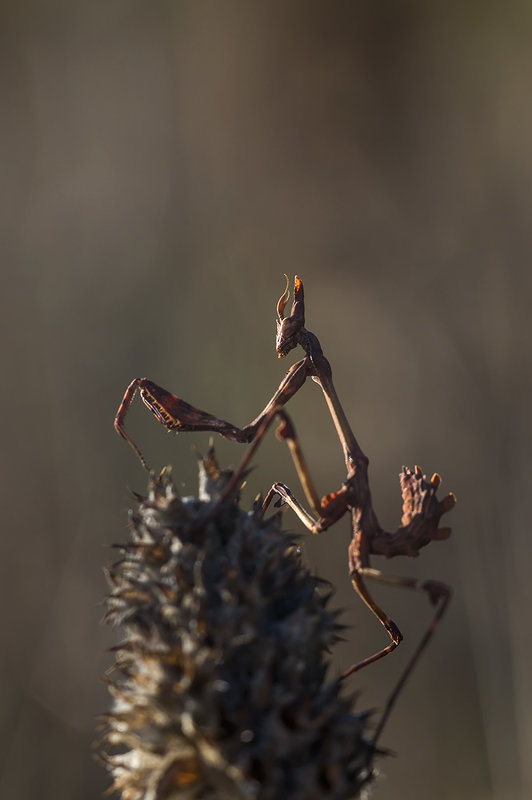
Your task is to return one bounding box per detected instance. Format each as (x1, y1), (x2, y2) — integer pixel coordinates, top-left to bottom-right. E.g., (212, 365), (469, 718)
(114, 276), (455, 744)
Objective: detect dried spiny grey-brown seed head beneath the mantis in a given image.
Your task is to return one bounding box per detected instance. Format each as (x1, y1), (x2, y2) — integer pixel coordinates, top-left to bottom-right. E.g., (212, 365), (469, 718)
(101, 451), (373, 800)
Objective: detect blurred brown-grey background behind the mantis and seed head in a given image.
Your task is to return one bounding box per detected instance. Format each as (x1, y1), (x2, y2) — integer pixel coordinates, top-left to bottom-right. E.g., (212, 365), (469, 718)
(0, 0), (532, 800)
